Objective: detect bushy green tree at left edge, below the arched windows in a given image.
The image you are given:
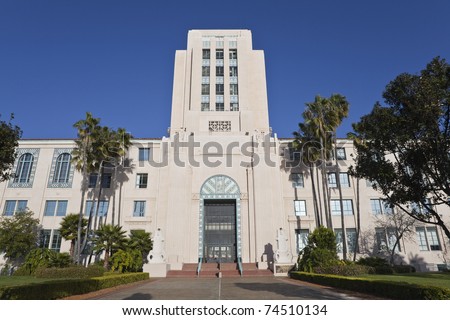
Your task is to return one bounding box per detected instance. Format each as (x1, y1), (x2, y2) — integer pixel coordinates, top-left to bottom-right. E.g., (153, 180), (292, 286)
(0, 210), (41, 266)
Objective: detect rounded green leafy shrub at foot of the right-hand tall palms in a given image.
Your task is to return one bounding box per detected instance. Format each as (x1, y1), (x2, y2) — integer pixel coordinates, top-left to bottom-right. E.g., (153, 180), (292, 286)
(297, 226), (338, 272)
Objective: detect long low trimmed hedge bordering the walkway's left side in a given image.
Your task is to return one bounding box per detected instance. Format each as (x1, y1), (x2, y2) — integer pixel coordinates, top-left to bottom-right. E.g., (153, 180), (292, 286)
(0, 272), (149, 300)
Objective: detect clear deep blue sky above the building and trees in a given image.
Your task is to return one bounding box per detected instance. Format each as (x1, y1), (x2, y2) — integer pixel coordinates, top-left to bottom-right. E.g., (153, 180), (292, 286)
(0, 0), (450, 138)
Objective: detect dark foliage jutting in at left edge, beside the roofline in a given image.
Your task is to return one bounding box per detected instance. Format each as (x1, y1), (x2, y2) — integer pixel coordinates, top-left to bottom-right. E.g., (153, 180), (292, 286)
(0, 114), (22, 182)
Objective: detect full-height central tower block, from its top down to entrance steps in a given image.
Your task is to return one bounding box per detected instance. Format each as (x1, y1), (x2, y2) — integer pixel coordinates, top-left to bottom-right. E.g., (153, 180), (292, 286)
(157, 30), (284, 270)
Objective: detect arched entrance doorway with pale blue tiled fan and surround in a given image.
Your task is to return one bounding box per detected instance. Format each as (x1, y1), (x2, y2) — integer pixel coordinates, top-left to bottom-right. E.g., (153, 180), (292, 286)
(198, 175), (241, 263)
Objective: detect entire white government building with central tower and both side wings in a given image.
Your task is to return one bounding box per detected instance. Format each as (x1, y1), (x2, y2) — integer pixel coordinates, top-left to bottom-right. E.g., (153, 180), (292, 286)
(0, 30), (450, 276)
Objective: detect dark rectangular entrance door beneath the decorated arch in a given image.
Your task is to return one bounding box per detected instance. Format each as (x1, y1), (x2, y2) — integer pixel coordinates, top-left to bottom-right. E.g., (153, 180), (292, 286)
(203, 200), (236, 262)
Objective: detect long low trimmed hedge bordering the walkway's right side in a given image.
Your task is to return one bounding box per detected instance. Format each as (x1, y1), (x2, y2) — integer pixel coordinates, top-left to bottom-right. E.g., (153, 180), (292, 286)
(290, 272), (450, 300)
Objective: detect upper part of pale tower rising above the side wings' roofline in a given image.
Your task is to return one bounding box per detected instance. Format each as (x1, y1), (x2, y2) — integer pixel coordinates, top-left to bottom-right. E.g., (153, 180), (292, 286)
(171, 30), (269, 135)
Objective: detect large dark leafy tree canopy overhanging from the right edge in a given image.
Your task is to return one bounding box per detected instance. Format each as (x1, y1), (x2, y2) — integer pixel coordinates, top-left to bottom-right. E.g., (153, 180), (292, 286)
(352, 57), (450, 239)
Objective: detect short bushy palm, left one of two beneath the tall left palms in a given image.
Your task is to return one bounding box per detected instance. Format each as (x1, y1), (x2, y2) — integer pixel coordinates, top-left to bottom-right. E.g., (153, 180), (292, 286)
(94, 224), (126, 269)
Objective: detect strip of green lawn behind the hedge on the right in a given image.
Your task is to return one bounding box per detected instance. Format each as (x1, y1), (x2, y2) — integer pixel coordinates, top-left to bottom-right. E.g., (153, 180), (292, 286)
(358, 272), (450, 289)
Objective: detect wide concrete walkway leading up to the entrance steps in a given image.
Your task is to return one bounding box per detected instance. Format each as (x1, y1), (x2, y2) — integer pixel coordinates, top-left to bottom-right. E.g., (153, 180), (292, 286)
(85, 277), (376, 300)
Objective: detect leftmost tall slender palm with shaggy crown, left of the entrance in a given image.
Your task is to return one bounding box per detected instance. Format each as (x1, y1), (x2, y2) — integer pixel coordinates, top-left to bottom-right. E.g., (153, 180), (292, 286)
(72, 112), (100, 264)
